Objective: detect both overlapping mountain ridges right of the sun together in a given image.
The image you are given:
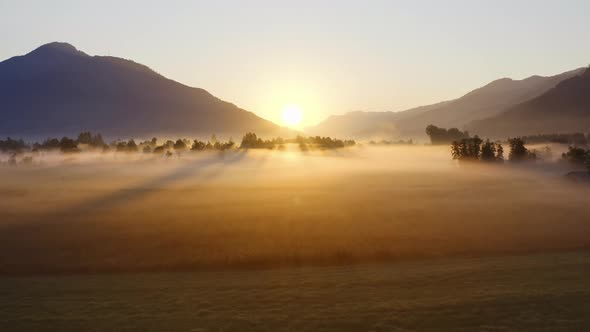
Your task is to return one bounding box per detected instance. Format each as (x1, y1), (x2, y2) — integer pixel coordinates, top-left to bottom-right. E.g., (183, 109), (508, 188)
(306, 68), (590, 139)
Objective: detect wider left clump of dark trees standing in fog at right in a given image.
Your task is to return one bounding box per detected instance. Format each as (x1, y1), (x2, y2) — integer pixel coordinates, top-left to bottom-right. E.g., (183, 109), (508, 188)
(451, 135), (504, 162)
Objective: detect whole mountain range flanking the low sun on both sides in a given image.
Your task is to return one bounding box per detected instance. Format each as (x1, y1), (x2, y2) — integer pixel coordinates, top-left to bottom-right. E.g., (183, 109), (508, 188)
(0, 43), (590, 139)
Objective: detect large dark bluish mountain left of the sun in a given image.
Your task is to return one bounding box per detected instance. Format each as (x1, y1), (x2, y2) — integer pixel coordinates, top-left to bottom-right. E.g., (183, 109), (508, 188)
(0, 43), (283, 137)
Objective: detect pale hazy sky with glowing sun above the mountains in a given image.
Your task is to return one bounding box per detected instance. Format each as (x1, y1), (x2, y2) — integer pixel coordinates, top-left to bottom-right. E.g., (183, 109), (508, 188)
(0, 0), (590, 127)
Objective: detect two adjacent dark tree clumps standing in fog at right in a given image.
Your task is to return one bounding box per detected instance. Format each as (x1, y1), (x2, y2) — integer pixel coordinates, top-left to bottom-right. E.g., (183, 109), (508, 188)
(451, 135), (537, 162)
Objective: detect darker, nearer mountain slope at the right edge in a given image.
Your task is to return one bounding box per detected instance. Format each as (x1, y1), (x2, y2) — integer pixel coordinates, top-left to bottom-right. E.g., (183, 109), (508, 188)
(467, 68), (590, 138)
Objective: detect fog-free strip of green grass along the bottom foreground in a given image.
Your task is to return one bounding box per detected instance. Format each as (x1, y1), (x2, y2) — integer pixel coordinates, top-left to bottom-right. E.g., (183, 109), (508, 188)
(0, 252), (590, 332)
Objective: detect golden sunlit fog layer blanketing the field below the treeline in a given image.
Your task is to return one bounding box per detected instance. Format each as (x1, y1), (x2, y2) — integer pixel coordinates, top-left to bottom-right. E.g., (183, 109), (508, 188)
(0, 146), (590, 273)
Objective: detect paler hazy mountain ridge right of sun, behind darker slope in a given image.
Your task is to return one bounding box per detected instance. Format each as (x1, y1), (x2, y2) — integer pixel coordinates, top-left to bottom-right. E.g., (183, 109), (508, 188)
(311, 68), (584, 138)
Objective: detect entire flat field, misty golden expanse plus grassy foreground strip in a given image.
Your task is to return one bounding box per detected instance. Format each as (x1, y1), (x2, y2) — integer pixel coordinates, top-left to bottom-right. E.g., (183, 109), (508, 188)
(0, 147), (590, 331)
